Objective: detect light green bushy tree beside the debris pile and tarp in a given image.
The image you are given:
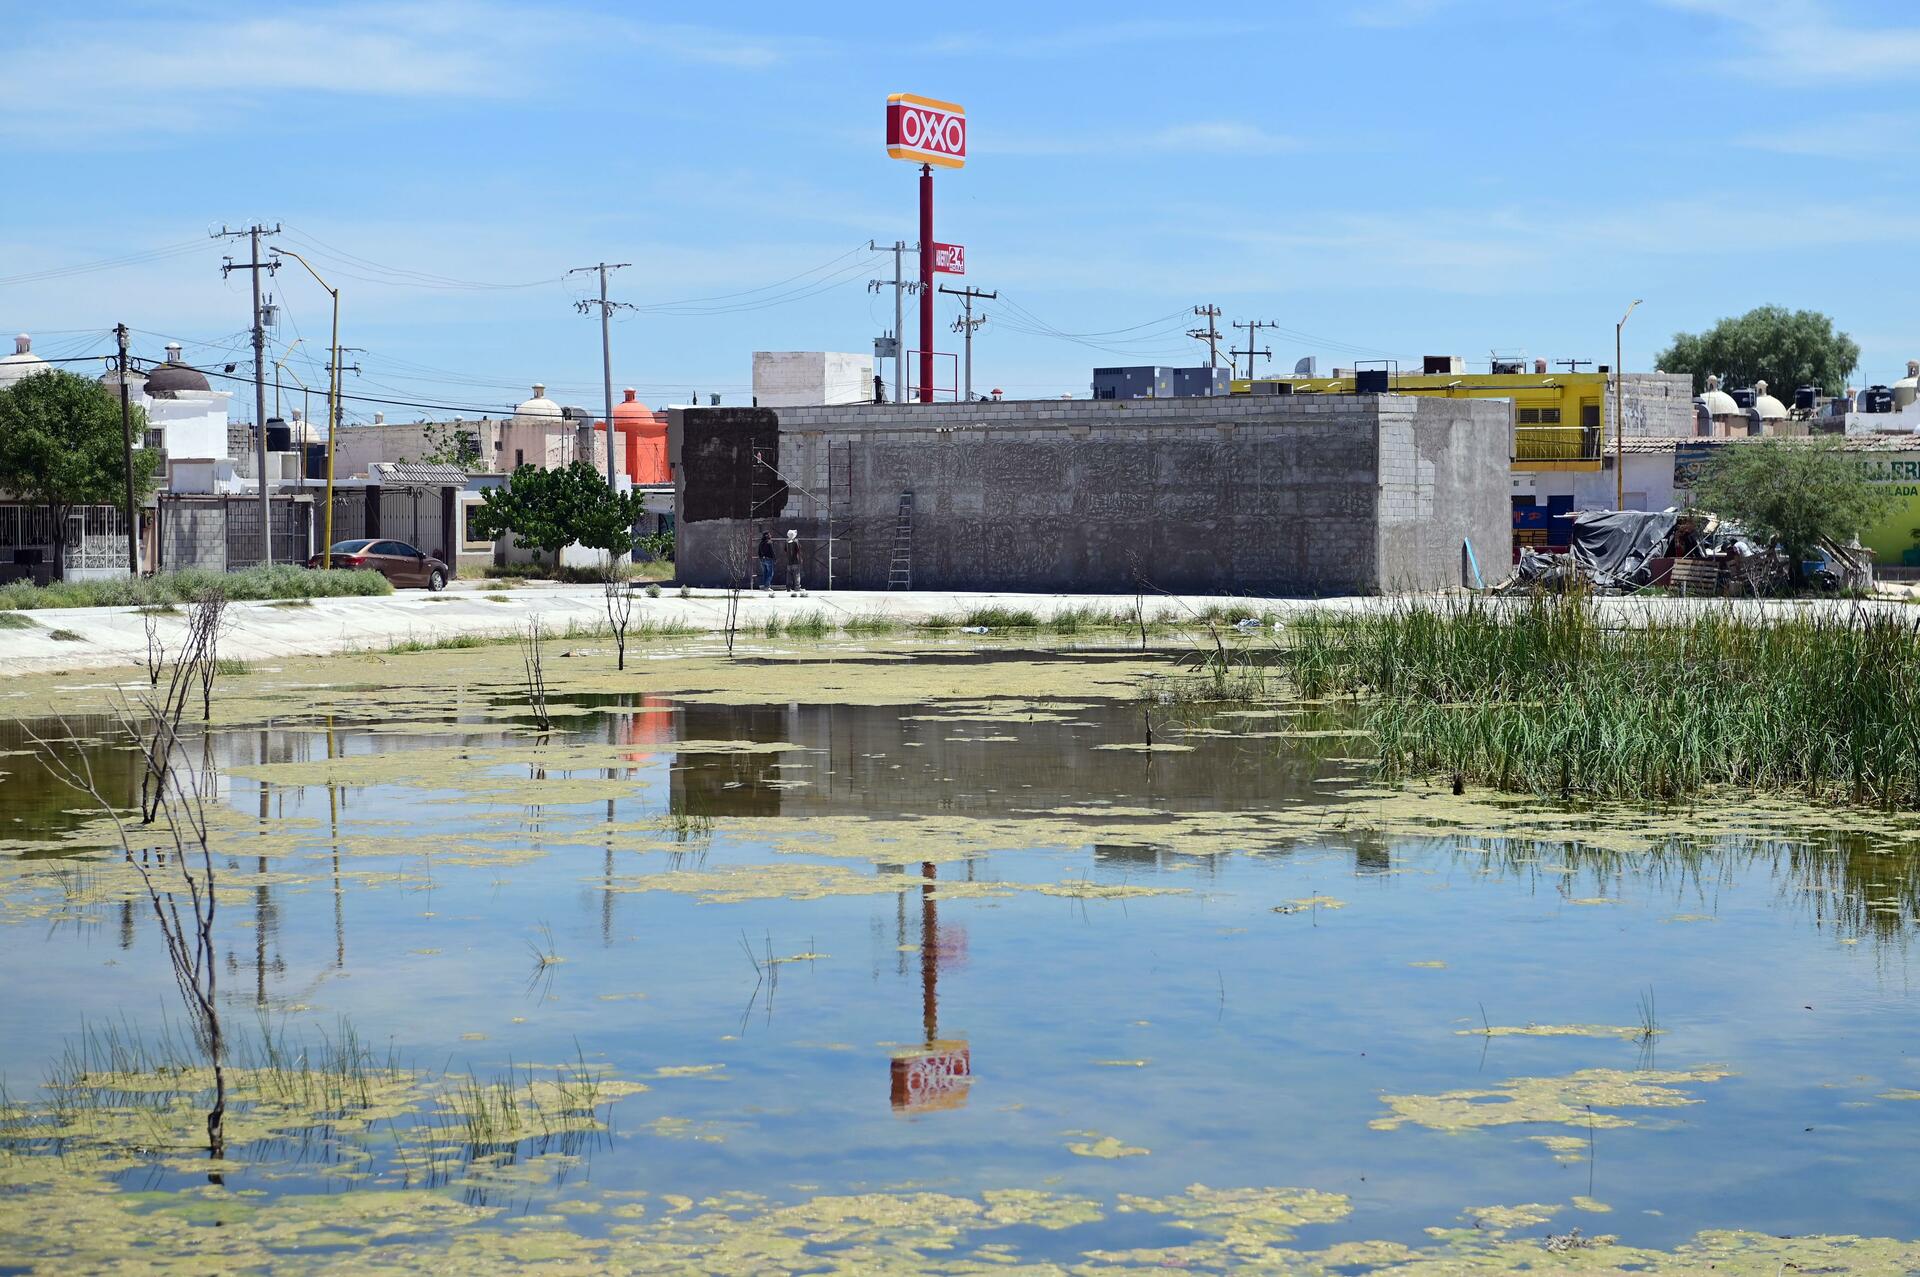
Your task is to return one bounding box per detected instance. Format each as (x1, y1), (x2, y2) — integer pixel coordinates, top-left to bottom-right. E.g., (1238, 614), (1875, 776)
(1693, 436), (1895, 586)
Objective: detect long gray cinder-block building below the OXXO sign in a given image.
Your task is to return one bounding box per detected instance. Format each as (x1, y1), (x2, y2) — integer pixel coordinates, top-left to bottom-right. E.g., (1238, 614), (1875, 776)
(668, 396), (1511, 595)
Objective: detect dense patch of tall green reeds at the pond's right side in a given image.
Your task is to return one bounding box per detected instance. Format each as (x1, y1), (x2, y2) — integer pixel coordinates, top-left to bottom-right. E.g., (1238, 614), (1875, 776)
(1279, 599), (1920, 808)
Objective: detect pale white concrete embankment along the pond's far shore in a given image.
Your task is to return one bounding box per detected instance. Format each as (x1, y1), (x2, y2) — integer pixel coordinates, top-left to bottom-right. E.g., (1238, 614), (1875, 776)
(0, 582), (1920, 676)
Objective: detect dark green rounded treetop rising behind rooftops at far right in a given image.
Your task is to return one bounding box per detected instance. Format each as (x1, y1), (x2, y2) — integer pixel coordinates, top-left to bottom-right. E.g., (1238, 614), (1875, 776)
(1653, 305), (1860, 399)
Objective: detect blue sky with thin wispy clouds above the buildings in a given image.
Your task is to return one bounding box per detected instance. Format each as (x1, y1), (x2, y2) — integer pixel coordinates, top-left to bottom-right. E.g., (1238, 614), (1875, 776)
(0, 0), (1920, 419)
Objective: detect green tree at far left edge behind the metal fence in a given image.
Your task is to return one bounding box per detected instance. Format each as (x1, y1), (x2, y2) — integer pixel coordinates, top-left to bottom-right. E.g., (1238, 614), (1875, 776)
(0, 371), (159, 572)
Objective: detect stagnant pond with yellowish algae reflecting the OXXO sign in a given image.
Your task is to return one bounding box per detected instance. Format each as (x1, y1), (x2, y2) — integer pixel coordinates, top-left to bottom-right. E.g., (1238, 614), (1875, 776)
(0, 647), (1920, 1273)
